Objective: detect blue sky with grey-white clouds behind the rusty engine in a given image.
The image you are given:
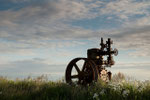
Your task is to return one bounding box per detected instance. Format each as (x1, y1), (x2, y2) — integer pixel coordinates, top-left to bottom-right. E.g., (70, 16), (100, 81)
(0, 0), (150, 80)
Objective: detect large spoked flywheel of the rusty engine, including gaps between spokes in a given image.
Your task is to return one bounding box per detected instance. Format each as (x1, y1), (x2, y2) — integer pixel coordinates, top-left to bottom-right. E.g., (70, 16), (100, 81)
(65, 58), (98, 85)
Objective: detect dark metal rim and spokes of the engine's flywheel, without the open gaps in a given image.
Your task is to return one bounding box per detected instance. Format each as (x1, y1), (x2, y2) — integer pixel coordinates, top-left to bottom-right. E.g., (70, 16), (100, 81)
(65, 58), (98, 84)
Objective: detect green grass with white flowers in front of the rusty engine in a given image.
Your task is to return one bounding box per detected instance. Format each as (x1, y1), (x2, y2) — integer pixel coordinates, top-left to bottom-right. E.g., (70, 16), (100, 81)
(0, 74), (150, 100)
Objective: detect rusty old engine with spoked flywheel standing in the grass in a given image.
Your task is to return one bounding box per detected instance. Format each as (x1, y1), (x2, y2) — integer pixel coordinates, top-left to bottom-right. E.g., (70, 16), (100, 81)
(65, 38), (118, 85)
